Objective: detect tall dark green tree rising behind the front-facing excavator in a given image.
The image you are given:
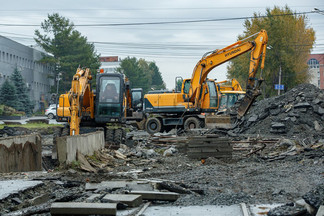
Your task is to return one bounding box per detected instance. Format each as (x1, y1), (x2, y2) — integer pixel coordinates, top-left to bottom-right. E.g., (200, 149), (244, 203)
(35, 13), (100, 93)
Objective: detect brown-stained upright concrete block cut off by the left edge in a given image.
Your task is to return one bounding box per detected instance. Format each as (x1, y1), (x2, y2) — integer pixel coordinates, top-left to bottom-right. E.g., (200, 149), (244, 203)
(0, 134), (42, 173)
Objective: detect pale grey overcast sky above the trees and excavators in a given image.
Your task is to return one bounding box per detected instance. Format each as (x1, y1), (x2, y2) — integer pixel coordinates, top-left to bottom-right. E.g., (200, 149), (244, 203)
(0, 0), (324, 89)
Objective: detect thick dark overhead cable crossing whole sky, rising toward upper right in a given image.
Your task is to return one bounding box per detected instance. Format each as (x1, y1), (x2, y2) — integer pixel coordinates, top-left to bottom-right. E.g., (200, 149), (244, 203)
(0, 11), (316, 27)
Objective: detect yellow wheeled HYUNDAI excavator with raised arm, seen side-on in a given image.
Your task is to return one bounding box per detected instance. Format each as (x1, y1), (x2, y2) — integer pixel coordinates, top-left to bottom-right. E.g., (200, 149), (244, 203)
(144, 30), (268, 133)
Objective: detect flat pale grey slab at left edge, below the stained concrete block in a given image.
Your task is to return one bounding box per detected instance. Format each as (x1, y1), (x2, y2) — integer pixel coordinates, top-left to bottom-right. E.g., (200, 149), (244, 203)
(0, 180), (43, 200)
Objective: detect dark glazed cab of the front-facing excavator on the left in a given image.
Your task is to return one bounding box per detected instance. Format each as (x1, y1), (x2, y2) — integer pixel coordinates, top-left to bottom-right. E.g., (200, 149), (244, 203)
(95, 73), (124, 123)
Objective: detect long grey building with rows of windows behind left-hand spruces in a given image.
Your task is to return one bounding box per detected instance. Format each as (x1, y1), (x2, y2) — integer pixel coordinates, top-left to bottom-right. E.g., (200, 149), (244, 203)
(0, 36), (54, 111)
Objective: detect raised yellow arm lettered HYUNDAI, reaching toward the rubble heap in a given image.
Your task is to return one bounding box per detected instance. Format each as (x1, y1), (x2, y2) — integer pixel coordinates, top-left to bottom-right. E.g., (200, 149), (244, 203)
(189, 30), (268, 115)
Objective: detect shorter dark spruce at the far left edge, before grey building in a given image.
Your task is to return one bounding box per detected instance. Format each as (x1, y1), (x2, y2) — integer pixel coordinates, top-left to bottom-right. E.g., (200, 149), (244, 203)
(0, 79), (18, 109)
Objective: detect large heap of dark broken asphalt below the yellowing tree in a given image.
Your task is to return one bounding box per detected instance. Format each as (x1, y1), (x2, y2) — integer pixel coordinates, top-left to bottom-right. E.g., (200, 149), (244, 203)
(230, 84), (324, 141)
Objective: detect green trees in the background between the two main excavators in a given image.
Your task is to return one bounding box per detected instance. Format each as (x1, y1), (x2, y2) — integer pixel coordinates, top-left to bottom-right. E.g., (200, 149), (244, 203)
(117, 57), (165, 93)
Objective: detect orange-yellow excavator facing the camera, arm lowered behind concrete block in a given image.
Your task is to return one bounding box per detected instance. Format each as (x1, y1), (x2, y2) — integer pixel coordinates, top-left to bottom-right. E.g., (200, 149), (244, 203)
(57, 68), (143, 144)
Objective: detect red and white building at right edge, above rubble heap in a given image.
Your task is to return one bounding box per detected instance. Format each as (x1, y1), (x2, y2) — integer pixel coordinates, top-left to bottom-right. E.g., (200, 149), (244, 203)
(307, 54), (324, 89)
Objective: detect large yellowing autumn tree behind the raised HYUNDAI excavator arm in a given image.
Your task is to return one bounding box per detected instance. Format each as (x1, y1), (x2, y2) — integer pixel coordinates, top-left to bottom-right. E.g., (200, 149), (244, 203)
(227, 6), (315, 97)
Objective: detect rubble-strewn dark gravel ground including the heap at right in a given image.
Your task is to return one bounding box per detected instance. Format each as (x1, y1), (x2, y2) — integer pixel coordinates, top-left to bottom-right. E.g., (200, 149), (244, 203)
(0, 83), (324, 215)
